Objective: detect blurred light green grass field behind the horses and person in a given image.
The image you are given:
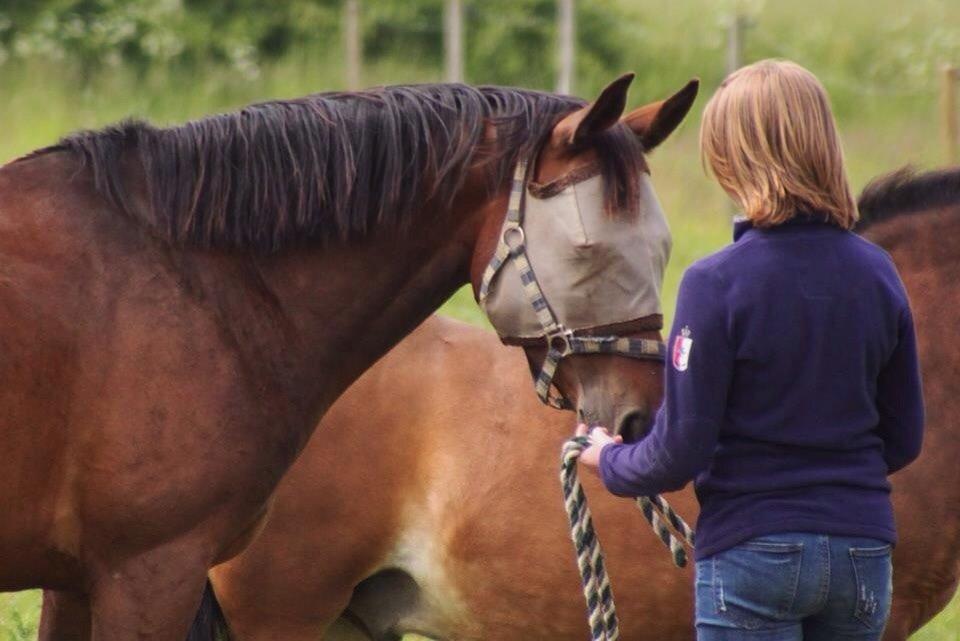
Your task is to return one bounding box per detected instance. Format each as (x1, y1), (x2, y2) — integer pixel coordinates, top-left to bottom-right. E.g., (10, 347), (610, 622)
(0, 0), (960, 641)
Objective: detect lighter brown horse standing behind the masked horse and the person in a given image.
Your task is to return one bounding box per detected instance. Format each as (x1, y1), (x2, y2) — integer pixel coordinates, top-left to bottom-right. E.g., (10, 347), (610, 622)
(202, 164), (960, 641)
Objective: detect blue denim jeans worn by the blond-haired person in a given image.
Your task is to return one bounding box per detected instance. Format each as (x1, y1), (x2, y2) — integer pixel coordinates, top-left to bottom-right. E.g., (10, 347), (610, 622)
(696, 533), (893, 641)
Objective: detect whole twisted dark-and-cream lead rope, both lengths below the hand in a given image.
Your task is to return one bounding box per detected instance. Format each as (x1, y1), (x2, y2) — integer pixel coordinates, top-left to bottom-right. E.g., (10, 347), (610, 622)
(560, 436), (694, 641)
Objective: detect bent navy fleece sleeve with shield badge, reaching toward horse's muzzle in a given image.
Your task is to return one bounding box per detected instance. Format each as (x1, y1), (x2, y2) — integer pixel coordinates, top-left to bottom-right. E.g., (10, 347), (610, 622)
(600, 265), (735, 496)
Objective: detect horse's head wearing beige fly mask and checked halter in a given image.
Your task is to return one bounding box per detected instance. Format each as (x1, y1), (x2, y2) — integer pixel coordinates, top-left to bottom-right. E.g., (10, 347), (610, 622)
(471, 74), (698, 440)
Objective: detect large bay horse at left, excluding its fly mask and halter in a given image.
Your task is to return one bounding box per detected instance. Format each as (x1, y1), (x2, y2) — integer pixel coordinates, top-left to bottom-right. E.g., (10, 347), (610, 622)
(0, 74), (696, 641)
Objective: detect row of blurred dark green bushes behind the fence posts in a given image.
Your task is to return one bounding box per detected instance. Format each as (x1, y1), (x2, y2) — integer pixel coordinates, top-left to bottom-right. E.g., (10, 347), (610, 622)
(0, 0), (622, 87)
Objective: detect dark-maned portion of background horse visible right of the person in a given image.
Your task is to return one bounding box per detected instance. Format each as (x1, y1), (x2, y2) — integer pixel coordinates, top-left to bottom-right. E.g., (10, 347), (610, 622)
(859, 168), (960, 641)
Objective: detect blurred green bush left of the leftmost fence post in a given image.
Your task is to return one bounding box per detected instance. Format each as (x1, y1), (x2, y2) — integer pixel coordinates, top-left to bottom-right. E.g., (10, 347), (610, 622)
(0, 0), (339, 71)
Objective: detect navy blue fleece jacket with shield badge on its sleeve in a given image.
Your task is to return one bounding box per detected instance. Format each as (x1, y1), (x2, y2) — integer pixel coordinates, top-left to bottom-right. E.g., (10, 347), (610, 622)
(600, 215), (923, 559)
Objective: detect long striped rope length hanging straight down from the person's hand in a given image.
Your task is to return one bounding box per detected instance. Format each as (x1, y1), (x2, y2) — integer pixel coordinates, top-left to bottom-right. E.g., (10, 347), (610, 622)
(560, 436), (620, 641)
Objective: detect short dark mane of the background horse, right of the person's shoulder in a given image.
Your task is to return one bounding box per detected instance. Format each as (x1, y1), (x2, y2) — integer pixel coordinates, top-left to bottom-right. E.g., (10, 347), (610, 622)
(857, 167), (960, 231)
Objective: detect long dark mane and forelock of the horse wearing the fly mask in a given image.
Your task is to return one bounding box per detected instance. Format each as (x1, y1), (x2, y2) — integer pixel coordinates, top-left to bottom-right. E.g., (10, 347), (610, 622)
(56, 84), (645, 252)
